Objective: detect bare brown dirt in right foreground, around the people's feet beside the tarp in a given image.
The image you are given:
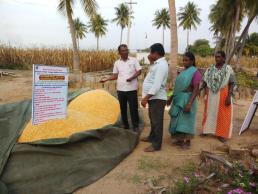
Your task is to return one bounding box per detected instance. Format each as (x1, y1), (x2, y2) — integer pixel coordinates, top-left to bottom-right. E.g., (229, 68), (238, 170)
(75, 101), (258, 194)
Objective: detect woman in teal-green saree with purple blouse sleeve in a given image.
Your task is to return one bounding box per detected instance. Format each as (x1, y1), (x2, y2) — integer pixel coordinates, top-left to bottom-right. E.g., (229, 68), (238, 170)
(167, 52), (202, 148)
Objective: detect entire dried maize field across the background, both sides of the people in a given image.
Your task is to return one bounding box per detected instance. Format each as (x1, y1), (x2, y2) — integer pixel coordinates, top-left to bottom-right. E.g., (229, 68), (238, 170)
(0, 45), (258, 73)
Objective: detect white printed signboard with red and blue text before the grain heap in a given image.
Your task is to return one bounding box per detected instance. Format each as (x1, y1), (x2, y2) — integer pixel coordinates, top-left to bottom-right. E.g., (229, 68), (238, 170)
(32, 65), (69, 125)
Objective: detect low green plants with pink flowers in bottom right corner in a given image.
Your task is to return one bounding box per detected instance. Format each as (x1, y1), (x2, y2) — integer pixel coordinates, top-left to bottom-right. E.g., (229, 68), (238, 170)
(170, 161), (258, 194)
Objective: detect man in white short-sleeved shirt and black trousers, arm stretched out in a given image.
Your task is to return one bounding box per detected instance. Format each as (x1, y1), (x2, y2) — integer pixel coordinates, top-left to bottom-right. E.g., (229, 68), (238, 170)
(101, 44), (142, 132)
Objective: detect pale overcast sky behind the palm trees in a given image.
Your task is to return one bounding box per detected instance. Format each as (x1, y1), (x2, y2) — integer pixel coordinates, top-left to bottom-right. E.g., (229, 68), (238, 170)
(0, 0), (258, 53)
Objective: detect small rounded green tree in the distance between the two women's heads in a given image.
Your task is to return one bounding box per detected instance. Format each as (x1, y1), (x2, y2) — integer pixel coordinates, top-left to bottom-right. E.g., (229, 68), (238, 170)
(189, 39), (213, 57)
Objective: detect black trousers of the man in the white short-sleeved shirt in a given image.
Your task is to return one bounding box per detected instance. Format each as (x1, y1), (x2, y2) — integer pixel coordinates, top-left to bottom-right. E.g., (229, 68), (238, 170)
(117, 90), (139, 129)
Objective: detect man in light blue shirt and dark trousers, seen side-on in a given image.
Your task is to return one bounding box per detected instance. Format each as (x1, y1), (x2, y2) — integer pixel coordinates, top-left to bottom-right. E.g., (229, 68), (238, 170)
(141, 43), (168, 152)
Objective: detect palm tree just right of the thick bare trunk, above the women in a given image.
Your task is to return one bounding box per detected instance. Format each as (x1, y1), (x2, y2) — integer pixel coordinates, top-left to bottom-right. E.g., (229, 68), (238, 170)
(177, 2), (201, 50)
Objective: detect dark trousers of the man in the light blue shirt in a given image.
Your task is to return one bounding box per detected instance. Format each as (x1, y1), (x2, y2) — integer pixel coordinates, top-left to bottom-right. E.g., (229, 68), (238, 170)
(148, 99), (166, 150)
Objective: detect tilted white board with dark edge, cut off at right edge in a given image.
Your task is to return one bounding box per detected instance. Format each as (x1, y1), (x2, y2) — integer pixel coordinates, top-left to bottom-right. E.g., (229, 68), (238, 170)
(239, 91), (258, 135)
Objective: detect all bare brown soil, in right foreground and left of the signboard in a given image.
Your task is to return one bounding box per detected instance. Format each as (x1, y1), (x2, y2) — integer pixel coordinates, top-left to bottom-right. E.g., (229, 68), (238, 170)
(0, 71), (258, 194)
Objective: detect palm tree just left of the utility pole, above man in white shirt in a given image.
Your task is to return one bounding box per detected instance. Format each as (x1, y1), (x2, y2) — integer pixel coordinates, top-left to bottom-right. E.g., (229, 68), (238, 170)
(112, 3), (131, 44)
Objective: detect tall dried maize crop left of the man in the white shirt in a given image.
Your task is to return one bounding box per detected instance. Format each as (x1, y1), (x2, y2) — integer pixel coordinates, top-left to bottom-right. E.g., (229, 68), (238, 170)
(0, 45), (118, 72)
